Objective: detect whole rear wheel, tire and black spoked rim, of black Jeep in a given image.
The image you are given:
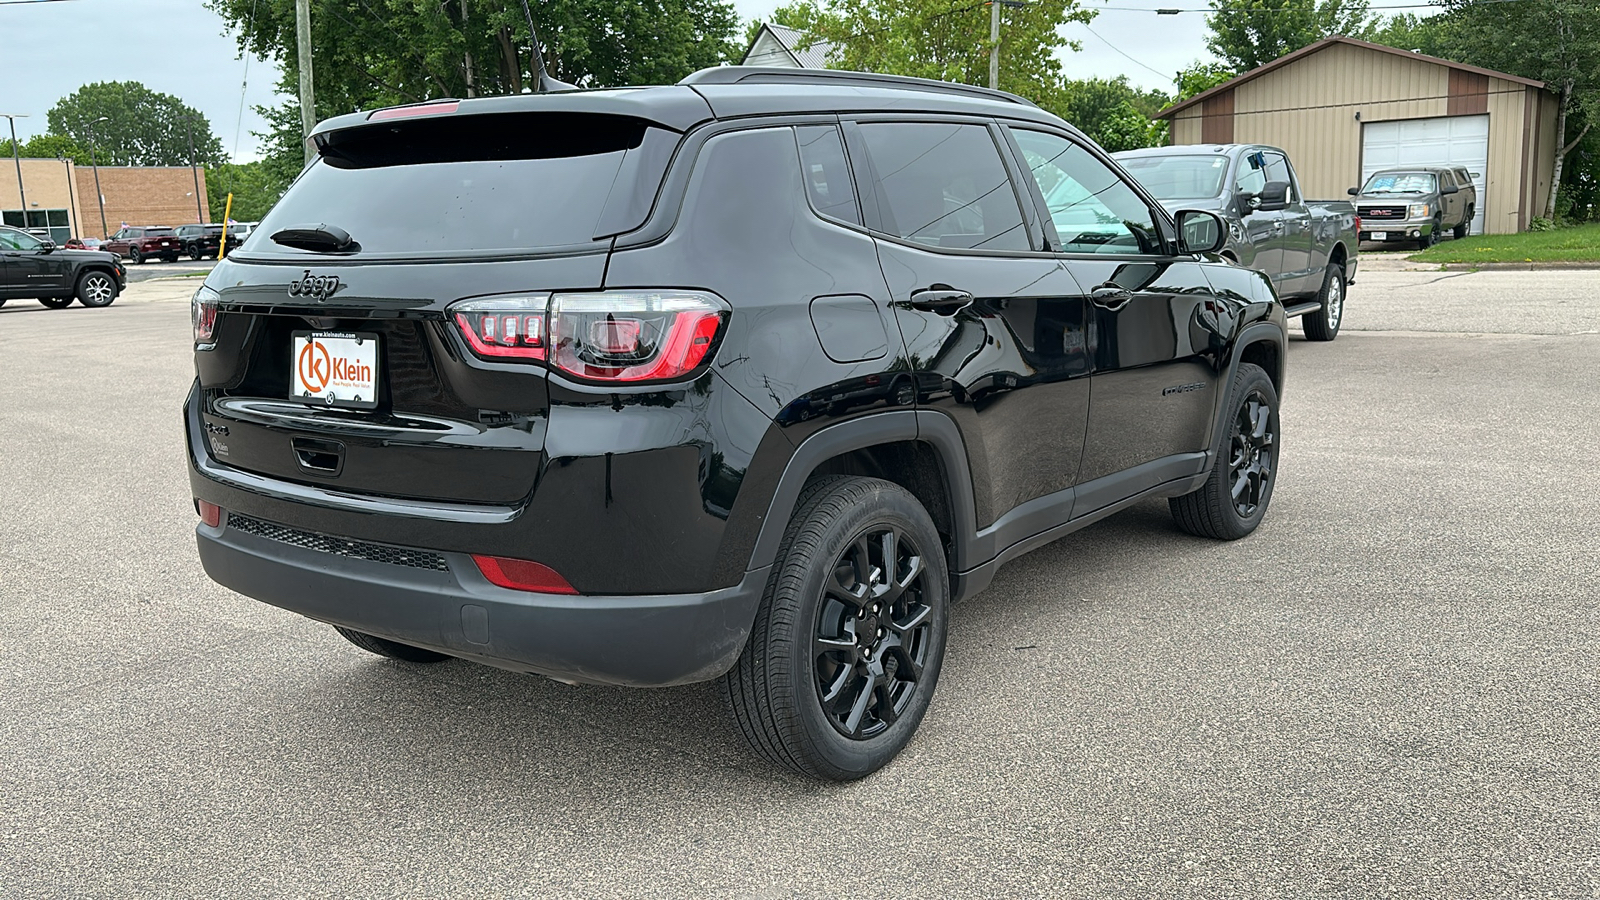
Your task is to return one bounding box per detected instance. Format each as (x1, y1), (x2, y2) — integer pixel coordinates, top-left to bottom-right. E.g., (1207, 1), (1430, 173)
(718, 476), (950, 781)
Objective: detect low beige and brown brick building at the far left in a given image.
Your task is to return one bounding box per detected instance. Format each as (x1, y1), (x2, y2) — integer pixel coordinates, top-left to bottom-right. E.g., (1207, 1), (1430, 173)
(0, 159), (211, 243)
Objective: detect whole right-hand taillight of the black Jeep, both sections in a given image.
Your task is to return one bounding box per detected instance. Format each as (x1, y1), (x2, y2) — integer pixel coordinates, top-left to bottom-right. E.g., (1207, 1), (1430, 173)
(450, 288), (730, 384)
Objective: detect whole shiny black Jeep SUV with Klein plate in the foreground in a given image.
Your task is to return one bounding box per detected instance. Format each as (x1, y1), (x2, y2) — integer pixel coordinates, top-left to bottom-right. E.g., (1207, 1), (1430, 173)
(186, 67), (1286, 780)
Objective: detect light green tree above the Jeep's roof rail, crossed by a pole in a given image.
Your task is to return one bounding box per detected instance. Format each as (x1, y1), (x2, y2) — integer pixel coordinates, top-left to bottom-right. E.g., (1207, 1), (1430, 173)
(764, 0), (1094, 104)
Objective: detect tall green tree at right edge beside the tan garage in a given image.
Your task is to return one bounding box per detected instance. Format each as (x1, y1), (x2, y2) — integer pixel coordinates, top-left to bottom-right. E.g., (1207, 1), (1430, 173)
(1440, 0), (1600, 219)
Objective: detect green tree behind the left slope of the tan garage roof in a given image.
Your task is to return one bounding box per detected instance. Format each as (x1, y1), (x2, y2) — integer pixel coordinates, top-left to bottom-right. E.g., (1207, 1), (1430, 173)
(1206, 0), (1370, 72)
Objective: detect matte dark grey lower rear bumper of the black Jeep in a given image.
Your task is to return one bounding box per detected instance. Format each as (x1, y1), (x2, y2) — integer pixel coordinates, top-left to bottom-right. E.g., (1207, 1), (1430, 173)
(195, 519), (768, 687)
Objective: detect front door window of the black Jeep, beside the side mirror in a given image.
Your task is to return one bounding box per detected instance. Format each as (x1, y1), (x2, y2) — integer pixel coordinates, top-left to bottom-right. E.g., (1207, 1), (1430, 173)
(1011, 128), (1162, 253)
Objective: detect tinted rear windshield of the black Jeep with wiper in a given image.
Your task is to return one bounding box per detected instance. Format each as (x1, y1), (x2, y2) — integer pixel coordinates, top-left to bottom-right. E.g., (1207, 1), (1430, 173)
(248, 112), (653, 258)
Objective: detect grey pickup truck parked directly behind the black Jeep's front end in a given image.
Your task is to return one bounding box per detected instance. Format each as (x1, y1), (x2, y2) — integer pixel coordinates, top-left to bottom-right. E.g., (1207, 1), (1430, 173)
(1112, 144), (1358, 341)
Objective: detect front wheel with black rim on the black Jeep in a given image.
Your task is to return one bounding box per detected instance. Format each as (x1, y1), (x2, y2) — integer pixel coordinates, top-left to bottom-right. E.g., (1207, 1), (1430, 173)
(1168, 362), (1278, 541)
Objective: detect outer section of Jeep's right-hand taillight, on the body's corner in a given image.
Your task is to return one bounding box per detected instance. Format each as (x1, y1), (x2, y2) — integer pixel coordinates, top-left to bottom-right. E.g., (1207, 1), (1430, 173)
(550, 290), (728, 383)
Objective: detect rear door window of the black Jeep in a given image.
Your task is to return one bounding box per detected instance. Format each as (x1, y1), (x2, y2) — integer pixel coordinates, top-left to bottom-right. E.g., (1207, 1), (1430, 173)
(861, 122), (1032, 251)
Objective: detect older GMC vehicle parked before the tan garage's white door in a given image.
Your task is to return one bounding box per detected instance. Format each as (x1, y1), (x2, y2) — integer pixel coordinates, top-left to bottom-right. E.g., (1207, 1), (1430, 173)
(1350, 167), (1478, 248)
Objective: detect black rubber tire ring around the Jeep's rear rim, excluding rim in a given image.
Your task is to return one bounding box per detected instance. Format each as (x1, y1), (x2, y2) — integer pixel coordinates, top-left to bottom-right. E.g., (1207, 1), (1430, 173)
(786, 485), (950, 778)
